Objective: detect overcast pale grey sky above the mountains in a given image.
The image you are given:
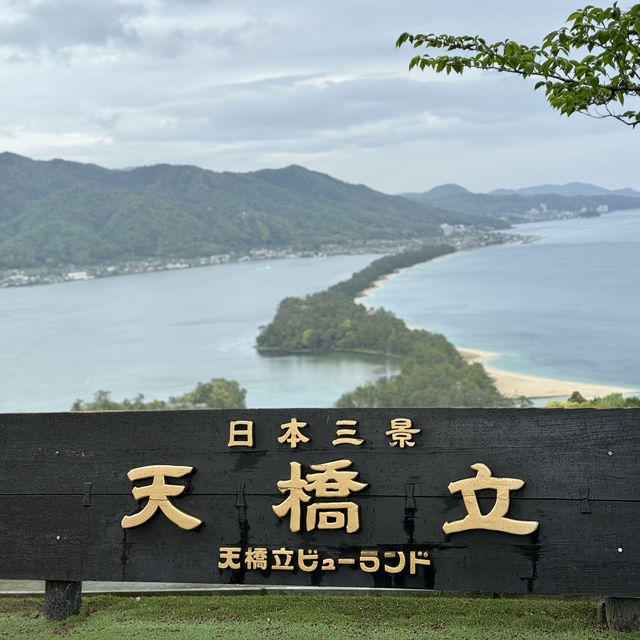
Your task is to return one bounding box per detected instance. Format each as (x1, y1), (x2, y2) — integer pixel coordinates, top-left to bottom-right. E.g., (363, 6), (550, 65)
(0, 0), (640, 193)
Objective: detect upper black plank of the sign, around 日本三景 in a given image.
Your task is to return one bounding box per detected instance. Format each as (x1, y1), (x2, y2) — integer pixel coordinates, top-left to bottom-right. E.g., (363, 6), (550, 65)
(0, 409), (640, 500)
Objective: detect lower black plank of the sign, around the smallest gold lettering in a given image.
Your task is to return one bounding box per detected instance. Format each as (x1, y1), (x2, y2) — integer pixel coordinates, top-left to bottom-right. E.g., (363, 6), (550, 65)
(0, 495), (640, 597)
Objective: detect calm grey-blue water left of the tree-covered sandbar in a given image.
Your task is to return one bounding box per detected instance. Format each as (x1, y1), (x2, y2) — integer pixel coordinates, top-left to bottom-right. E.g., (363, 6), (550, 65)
(0, 255), (398, 412)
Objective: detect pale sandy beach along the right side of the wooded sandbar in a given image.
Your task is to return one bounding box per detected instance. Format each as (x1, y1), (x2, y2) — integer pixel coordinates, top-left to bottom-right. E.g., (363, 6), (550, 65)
(353, 260), (638, 400)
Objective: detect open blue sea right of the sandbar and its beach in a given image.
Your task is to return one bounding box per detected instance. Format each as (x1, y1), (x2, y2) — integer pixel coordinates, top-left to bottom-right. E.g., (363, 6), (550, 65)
(368, 211), (640, 389)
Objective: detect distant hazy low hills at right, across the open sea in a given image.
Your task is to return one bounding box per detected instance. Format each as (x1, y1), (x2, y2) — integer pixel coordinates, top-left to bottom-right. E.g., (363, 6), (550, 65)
(403, 183), (640, 222)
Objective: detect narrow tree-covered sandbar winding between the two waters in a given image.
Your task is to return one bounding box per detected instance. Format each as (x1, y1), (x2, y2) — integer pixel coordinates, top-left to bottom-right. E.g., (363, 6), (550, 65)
(256, 245), (513, 407)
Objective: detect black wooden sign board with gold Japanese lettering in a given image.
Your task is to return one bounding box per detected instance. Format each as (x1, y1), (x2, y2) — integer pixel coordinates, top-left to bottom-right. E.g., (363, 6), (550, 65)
(0, 409), (640, 597)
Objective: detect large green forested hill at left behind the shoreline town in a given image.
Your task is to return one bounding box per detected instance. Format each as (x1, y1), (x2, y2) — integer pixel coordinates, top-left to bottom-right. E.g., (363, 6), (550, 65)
(0, 153), (497, 268)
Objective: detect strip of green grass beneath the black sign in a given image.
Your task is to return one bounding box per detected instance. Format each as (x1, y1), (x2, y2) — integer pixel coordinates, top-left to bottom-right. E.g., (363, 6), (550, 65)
(0, 594), (640, 640)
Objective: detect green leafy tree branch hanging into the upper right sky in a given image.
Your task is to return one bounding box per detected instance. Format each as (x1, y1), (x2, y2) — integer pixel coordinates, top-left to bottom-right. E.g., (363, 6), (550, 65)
(396, 3), (640, 127)
